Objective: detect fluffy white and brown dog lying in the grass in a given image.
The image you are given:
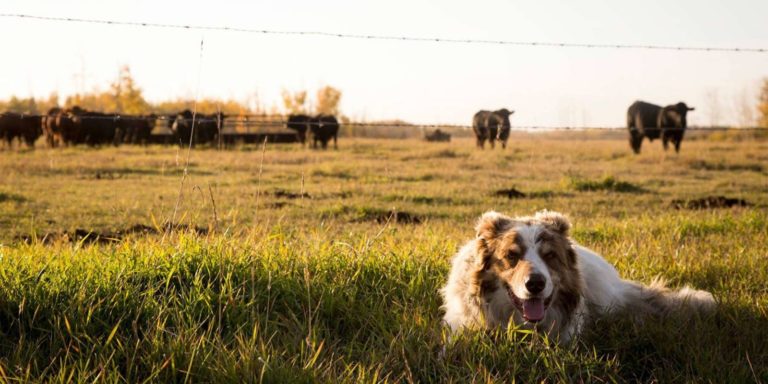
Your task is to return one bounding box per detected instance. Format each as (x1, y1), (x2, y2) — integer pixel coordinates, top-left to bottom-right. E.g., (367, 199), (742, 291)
(441, 211), (715, 343)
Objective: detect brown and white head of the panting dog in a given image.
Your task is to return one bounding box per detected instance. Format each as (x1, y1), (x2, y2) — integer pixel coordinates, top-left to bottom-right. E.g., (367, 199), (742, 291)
(476, 211), (581, 323)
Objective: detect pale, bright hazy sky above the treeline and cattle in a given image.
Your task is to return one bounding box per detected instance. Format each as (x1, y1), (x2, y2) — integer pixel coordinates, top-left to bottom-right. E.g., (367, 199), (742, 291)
(0, 0), (768, 127)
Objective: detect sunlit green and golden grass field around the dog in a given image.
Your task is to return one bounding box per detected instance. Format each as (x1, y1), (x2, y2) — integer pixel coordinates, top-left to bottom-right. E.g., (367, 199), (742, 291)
(0, 132), (768, 383)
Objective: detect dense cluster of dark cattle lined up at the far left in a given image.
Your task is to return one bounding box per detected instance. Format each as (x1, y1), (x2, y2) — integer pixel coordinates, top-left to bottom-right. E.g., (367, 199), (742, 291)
(0, 107), (339, 148)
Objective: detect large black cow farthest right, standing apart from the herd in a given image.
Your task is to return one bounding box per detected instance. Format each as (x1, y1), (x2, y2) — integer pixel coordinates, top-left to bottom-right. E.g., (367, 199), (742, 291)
(627, 101), (695, 153)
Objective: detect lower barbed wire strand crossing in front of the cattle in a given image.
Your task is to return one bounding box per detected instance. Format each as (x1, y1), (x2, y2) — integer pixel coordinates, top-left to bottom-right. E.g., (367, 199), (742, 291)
(0, 113), (768, 131)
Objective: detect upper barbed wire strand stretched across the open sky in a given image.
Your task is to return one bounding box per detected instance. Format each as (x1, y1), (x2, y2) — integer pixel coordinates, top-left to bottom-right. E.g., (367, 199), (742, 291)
(0, 13), (768, 53)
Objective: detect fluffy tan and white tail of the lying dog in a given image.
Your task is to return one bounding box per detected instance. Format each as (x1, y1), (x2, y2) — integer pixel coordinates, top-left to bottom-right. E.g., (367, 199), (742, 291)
(626, 278), (717, 316)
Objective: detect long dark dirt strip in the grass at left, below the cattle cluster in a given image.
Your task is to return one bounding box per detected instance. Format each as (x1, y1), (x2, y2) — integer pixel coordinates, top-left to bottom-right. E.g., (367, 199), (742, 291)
(17, 224), (208, 244)
